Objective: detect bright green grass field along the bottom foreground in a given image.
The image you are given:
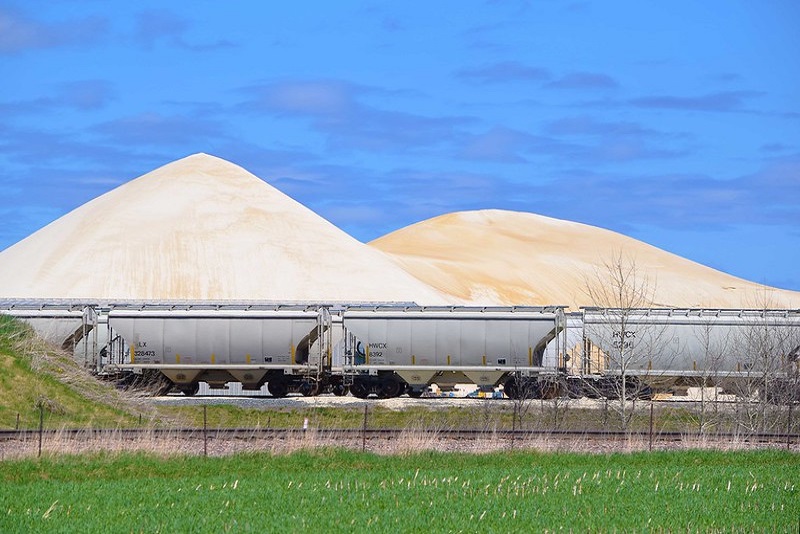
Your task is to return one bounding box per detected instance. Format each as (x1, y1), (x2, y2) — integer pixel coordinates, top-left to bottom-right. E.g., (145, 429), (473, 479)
(0, 449), (800, 532)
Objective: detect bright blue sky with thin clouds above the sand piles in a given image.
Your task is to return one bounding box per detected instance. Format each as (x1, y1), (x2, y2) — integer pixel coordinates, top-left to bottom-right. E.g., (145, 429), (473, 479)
(0, 0), (800, 290)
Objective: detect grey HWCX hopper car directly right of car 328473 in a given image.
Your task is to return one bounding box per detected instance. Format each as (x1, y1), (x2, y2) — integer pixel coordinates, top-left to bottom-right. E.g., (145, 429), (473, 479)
(342, 306), (564, 397)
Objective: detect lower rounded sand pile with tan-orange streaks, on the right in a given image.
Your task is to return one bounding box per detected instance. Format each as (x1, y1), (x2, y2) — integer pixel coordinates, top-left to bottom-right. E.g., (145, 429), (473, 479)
(370, 210), (800, 308)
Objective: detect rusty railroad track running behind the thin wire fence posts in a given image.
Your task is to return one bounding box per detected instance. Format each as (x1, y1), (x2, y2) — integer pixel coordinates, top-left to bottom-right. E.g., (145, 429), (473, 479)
(0, 427), (800, 443)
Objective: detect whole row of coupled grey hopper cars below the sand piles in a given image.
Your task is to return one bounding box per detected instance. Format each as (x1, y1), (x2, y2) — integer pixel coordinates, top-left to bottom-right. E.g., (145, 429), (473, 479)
(0, 300), (800, 399)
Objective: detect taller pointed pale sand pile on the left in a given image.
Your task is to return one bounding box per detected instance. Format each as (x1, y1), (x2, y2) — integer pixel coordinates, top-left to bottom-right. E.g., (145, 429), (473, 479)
(0, 154), (452, 304)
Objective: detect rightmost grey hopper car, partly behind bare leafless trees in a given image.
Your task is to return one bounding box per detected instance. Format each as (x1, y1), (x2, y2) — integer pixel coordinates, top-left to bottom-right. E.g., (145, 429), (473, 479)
(580, 308), (800, 396)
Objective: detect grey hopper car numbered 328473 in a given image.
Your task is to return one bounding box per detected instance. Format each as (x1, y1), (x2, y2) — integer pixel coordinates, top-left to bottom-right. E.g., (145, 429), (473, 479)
(109, 305), (320, 396)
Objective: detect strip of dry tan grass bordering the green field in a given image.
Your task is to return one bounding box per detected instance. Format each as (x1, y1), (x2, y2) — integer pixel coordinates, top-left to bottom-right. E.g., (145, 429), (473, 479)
(0, 426), (798, 461)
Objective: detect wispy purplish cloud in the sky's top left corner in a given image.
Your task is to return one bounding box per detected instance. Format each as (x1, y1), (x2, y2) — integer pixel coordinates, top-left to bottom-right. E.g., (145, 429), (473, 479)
(0, 6), (109, 54)
